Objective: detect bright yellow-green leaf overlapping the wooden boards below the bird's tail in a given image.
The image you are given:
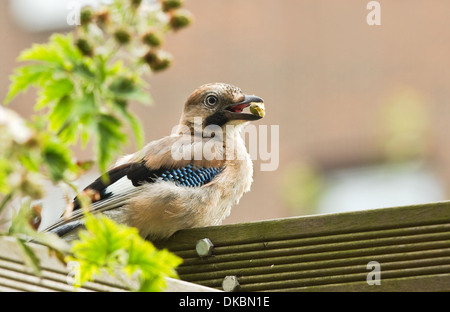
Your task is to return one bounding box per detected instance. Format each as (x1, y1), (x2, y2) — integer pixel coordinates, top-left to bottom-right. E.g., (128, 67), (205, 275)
(67, 213), (182, 291)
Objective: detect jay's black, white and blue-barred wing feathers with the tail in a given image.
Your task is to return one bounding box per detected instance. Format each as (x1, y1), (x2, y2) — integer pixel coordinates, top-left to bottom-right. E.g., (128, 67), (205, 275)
(47, 162), (224, 236)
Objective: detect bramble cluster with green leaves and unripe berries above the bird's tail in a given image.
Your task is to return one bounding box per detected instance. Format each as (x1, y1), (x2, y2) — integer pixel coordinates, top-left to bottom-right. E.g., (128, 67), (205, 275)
(6, 0), (191, 172)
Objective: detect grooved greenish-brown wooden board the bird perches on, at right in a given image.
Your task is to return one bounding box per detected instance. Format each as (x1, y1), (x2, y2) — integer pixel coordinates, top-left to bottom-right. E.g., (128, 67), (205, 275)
(156, 202), (450, 291)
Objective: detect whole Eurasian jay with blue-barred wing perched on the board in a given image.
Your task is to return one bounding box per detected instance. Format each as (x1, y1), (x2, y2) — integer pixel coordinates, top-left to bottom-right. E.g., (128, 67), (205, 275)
(43, 83), (263, 240)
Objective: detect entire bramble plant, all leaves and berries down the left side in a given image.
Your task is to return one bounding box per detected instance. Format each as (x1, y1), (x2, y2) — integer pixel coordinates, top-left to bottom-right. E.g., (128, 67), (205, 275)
(0, 0), (192, 290)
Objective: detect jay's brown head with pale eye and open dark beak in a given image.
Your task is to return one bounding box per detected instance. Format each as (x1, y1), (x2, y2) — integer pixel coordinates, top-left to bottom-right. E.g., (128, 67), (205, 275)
(180, 83), (263, 129)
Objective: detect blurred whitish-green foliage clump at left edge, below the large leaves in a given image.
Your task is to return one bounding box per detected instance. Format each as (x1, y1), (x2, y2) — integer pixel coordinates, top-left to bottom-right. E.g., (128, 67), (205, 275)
(0, 106), (80, 223)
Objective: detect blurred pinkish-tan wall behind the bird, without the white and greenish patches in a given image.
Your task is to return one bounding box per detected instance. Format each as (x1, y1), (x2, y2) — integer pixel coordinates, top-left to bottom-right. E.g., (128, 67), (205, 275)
(0, 0), (450, 223)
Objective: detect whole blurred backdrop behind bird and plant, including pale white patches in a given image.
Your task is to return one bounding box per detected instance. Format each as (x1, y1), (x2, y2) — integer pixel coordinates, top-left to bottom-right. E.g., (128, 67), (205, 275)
(0, 0), (450, 228)
